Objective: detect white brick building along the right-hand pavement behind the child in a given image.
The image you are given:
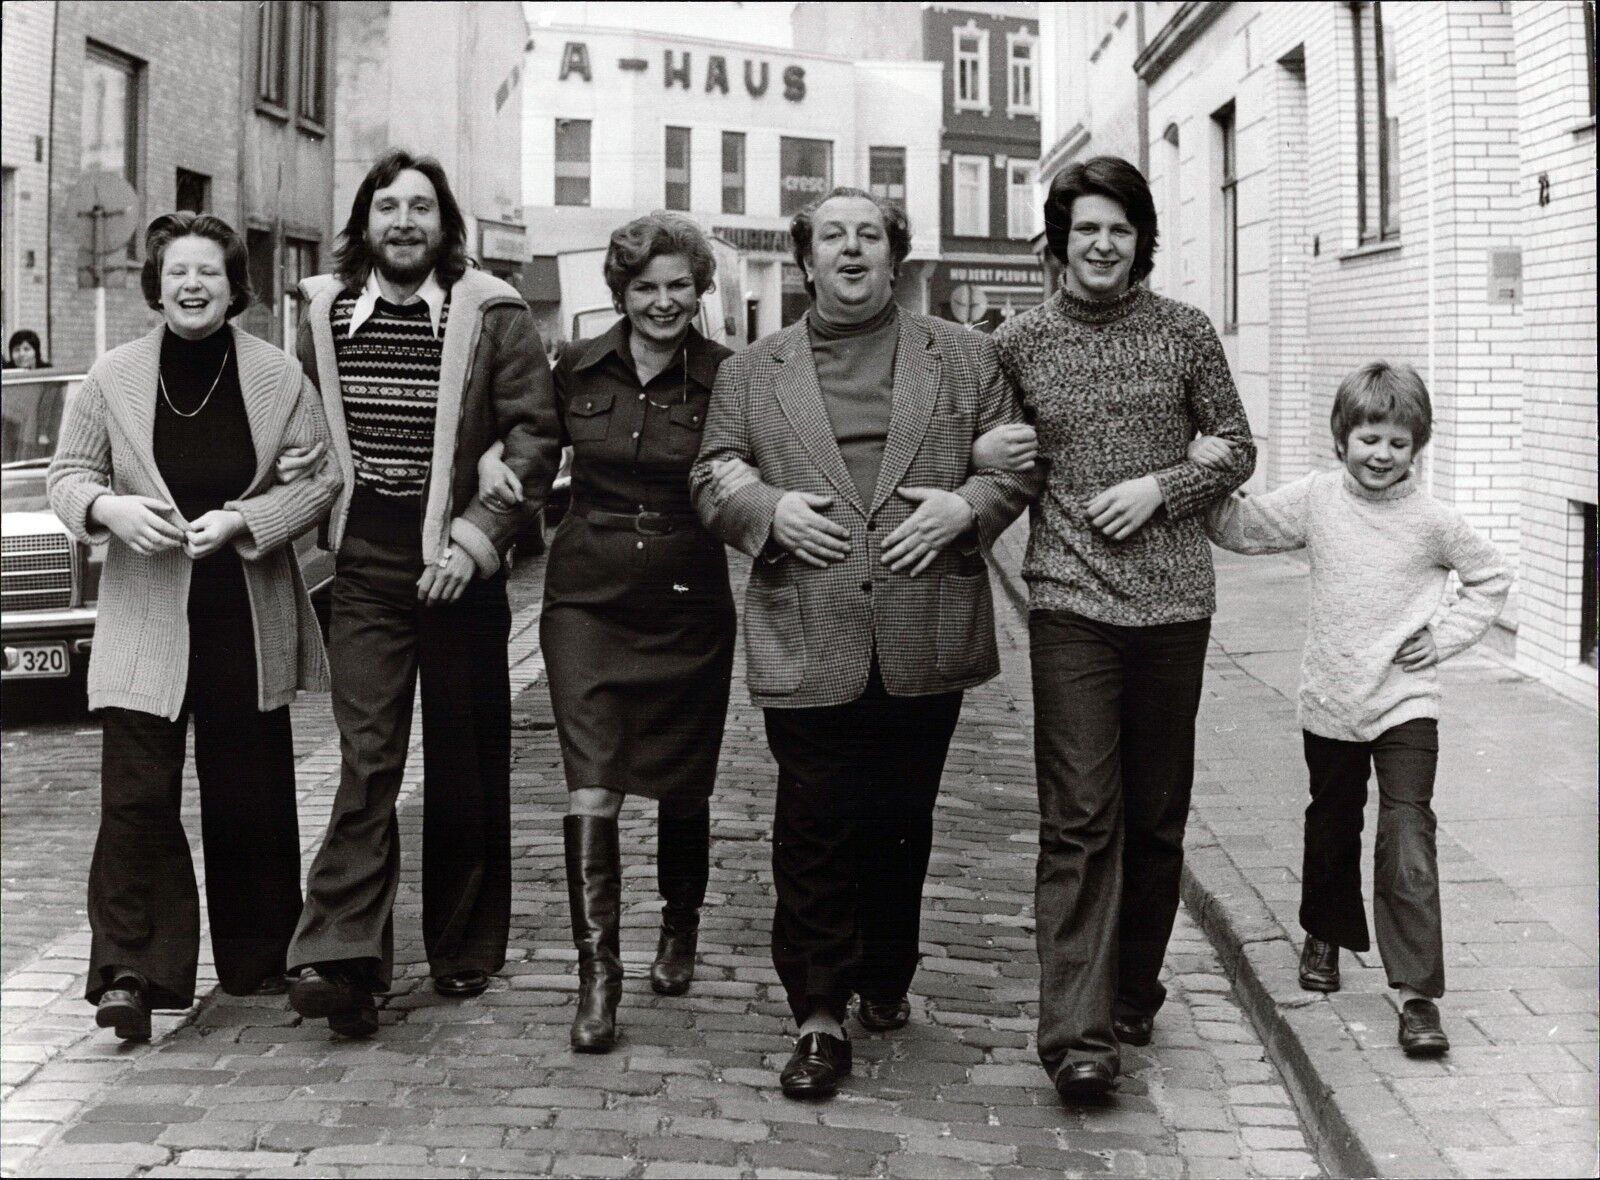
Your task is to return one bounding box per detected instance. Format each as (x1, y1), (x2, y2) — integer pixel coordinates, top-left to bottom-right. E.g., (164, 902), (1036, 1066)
(1045, 0), (1595, 700)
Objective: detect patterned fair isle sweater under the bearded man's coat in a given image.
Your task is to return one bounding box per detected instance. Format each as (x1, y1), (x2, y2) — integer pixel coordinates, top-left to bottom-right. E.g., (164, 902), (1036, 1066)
(331, 293), (450, 500)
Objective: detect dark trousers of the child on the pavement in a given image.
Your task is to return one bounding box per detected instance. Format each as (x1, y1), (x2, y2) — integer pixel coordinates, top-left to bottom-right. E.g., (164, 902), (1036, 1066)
(1299, 718), (1445, 999)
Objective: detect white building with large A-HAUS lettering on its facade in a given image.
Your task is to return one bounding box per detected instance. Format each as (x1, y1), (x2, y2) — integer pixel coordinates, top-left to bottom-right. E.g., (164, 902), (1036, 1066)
(523, 24), (939, 341)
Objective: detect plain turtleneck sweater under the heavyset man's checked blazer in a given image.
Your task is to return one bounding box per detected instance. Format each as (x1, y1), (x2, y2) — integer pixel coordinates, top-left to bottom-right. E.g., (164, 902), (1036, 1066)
(806, 301), (899, 507)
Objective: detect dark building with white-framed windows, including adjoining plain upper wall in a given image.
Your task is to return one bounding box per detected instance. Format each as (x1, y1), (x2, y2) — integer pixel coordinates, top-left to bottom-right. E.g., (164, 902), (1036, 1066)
(790, 3), (1043, 331)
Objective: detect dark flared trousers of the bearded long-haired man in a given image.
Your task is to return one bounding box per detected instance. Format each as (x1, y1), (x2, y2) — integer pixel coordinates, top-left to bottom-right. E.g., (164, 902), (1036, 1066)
(290, 536), (510, 990)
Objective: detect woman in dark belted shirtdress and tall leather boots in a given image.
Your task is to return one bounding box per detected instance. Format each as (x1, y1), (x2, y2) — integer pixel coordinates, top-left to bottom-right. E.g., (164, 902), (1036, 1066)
(486, 213), (736, 1052)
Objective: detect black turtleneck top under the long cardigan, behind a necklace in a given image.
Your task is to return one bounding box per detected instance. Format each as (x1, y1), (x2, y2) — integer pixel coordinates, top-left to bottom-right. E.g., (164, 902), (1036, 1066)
(150, 325), (256, 617)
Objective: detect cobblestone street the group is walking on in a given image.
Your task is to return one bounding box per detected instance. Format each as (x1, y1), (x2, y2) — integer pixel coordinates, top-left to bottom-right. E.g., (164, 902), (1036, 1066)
(0, 563), (1317, 1177)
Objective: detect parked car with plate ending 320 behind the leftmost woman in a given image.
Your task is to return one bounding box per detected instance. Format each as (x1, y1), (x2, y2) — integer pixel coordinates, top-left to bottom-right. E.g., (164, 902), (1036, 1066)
(0, 369), (333, 684)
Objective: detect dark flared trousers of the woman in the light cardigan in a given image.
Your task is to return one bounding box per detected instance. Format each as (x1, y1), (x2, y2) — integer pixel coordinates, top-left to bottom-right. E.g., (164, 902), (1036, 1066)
(85, 600), (301, 1007)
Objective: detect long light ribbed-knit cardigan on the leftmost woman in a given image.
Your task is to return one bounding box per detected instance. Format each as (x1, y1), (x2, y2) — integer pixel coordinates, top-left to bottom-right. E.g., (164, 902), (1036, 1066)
(46, 325), (339, 721)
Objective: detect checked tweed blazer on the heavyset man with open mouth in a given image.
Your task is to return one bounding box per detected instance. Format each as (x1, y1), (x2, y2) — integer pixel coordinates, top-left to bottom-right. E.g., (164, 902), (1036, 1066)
(690, 310), (1037, 708)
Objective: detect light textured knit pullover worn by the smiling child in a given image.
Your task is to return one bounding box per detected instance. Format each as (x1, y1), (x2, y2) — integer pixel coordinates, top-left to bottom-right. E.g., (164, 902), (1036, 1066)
(1208, 467), (1510, 742)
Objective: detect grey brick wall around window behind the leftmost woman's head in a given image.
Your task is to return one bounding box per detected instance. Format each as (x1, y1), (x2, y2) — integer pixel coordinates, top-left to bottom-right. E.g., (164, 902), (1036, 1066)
(47, 0), (240, 368)
